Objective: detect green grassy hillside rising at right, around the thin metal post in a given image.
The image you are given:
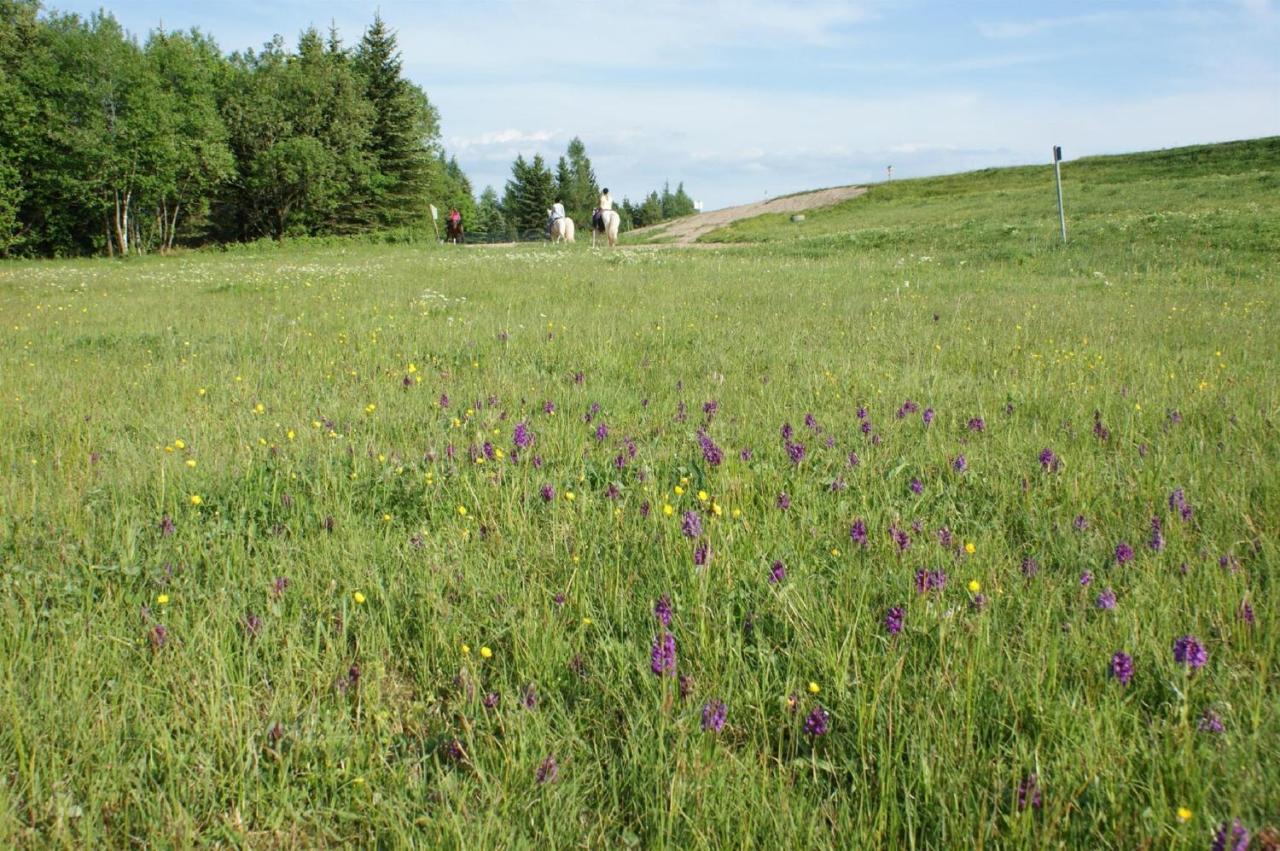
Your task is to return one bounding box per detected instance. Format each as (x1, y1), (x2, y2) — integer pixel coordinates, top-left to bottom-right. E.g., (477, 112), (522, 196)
(701, 137), (1280, 274)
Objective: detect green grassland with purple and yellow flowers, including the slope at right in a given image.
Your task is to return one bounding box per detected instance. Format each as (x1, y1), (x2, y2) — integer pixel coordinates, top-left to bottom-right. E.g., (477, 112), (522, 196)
(0, 139), (1280, 848)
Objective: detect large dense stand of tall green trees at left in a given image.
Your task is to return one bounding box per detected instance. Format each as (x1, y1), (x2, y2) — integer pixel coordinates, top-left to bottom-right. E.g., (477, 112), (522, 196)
(0, 0), (475, 256)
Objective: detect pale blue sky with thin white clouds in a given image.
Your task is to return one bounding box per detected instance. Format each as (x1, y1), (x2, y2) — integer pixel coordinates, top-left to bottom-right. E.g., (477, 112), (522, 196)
(45, 0), (1280, 210)
